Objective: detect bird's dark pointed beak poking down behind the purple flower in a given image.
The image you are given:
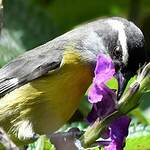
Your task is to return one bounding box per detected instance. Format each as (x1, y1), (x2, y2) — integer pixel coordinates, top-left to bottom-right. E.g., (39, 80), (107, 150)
(115, 71), (133, 100)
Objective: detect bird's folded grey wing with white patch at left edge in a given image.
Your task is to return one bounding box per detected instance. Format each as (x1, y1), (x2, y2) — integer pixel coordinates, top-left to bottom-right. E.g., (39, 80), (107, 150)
(0, 43), (63, 97)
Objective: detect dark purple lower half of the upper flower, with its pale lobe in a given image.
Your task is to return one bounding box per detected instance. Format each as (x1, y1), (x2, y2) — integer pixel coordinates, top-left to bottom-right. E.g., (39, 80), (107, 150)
(87, 84), (117, 123)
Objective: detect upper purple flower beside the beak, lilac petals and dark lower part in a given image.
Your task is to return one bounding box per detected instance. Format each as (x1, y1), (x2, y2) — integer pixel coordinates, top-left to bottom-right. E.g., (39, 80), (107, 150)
(87, 54), (117, 122)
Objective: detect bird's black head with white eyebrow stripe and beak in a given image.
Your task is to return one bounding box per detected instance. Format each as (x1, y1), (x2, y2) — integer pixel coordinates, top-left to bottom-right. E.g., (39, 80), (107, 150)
(92, 17), (146, 96)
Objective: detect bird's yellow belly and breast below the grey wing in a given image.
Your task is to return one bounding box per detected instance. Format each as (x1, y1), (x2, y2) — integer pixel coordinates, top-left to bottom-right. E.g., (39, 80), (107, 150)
(0, 49), (93, 134)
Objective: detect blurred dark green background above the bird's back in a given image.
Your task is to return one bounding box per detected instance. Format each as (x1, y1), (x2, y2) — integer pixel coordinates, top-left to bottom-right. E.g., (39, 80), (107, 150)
(0, 0), (150, 125)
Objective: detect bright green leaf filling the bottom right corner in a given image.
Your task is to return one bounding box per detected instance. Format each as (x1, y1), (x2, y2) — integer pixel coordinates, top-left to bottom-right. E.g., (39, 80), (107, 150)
(125, 124), (150, 150)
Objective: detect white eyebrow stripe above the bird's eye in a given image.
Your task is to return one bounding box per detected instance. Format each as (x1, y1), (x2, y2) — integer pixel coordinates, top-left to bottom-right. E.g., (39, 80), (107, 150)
(108, 20), (129, 64)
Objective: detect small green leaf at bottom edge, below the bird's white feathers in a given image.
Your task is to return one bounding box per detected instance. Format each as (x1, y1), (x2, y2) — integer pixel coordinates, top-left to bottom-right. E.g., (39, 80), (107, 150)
(27, 135), (56, 150)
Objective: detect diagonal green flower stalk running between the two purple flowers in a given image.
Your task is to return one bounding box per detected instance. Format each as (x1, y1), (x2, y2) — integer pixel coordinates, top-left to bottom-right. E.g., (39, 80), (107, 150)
(80, 63), (150, 147)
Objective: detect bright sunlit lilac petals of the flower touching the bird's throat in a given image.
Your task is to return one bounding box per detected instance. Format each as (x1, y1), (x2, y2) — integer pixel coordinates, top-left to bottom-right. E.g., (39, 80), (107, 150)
(88, 54), (115, 103)
